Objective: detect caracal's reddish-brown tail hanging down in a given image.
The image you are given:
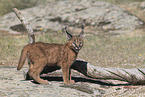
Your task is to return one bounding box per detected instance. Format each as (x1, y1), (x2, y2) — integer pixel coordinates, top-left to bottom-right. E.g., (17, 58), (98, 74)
(17, 45), (29, 70)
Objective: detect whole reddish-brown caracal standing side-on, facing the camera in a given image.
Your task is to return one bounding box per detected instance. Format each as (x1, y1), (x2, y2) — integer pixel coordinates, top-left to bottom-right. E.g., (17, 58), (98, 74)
(17, 29), (83, 85)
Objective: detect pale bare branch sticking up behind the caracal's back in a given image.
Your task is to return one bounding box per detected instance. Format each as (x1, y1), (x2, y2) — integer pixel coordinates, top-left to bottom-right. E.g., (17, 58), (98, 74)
(13, 8), (35, 43)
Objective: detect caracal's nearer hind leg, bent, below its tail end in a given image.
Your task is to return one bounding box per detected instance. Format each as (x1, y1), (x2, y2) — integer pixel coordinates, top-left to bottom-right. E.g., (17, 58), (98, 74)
(28, 58), (49, 84)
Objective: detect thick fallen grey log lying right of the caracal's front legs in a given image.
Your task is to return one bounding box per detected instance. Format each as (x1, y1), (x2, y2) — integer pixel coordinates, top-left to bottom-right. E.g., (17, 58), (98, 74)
(72, 60), (145, 84)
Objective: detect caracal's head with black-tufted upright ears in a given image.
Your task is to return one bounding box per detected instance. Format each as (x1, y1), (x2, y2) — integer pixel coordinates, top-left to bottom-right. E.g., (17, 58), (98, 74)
(65, 27), (84, 52)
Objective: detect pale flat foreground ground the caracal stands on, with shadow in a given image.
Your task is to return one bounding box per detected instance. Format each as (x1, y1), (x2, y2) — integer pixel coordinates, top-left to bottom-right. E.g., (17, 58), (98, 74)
(0, 66), (145, 97)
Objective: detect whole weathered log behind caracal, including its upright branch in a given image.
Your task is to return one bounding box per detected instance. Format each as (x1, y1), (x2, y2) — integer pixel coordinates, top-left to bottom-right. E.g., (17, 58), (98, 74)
(13, 9), (145, 84)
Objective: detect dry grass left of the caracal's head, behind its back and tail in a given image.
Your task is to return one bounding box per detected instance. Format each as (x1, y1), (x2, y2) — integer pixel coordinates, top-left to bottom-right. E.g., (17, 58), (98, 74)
(0, 31), (65, 65)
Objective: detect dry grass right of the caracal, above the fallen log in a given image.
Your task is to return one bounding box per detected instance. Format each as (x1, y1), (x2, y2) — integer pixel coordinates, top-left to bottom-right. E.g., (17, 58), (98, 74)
(81, 29), (145, 68)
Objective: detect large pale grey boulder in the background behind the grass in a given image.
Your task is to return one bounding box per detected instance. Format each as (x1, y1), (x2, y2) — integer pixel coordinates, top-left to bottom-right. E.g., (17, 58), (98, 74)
(0, 0), (143, 31)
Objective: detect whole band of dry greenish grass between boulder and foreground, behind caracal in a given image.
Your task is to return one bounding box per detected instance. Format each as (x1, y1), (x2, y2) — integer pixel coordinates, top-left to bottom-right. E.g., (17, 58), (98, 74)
(0, 31), (145, 68)
